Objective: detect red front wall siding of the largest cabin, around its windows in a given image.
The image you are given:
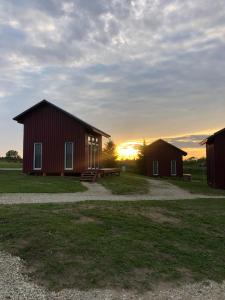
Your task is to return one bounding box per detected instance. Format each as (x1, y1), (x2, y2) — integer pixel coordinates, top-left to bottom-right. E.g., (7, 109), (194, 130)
(20, 105), (102, 173)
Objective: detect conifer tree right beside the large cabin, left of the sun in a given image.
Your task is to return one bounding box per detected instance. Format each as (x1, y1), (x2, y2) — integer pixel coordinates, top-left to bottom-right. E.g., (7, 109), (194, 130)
(102, 140), (117, 168)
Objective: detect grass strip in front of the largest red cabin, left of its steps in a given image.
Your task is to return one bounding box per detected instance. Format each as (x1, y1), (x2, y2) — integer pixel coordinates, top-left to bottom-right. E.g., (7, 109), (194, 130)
(0, 171), (86, 193)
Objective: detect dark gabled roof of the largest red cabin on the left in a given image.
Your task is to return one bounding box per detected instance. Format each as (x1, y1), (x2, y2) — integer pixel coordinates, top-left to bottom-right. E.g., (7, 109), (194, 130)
(13, 100), (110, 138)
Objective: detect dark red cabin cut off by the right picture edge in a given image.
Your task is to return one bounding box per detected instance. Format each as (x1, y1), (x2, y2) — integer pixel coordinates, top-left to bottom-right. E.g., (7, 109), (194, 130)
(201, 128), (225, 189)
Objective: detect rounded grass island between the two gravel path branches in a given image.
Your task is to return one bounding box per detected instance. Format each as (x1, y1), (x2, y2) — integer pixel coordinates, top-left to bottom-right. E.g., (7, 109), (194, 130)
(98, 173), (149, 195)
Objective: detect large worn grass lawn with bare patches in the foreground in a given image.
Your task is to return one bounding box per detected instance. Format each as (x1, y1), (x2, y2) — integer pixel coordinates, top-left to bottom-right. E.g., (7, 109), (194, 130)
(0, 199), (225, 291)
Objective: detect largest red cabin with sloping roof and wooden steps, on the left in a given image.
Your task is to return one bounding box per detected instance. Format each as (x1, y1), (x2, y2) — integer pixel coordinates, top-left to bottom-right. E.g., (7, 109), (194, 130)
(14, 100), (110, 175)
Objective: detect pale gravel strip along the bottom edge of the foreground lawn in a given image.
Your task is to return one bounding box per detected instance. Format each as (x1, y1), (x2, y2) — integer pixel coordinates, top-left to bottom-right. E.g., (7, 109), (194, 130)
(0, 251), (225, 300)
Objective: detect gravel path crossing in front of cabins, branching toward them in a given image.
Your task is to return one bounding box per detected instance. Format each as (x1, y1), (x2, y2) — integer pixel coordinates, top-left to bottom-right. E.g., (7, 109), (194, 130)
(0, 179), (224, 204)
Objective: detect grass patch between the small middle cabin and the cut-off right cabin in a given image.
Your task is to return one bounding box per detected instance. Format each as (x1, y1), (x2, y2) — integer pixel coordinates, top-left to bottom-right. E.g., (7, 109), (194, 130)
(169, 170), (225, 196)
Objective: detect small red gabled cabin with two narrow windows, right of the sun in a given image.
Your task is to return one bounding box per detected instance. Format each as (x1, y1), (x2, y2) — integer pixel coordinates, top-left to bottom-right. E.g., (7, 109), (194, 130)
(146, 139), (187, 177)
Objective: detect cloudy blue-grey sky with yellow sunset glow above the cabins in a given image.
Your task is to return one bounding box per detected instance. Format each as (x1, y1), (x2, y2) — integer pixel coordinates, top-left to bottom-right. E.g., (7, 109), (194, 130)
(0, 0), (225, 158)
